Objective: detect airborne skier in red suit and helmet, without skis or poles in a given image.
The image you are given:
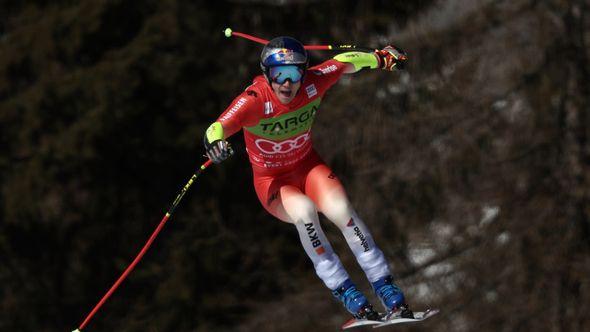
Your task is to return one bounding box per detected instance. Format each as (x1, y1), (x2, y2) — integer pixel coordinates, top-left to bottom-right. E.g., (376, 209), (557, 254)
(204, 37), (413, 320)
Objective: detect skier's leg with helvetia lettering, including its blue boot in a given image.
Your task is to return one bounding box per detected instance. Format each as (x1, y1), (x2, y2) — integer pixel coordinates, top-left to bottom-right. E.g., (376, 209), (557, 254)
(305, 164), (411, 316)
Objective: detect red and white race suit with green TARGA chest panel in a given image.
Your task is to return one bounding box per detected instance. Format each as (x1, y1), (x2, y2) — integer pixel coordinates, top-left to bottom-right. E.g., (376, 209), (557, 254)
(217, 59), (389, 289)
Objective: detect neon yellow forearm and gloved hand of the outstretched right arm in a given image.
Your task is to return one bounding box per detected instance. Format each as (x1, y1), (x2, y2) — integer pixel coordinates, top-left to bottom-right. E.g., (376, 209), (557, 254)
(334, 46), (407, 74)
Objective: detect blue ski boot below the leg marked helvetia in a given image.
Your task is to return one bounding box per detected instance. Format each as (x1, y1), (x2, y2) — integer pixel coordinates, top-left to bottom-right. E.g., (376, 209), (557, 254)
(372, 276), (414, 319)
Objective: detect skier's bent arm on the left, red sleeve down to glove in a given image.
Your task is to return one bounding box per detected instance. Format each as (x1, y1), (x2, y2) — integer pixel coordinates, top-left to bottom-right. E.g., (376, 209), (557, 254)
(203, 91), (257, 164)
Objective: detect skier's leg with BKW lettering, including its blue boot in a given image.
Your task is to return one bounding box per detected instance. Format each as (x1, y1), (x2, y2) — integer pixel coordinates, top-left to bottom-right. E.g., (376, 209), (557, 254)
(255, 176), (377, 319)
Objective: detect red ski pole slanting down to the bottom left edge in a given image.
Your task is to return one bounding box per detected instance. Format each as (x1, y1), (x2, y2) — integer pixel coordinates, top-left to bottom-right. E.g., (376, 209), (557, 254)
(72, 160), (212, 332)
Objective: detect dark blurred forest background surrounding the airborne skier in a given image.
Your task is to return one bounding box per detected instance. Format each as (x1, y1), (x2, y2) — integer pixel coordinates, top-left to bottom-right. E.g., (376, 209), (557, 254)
(0, 0), (590, 331)
